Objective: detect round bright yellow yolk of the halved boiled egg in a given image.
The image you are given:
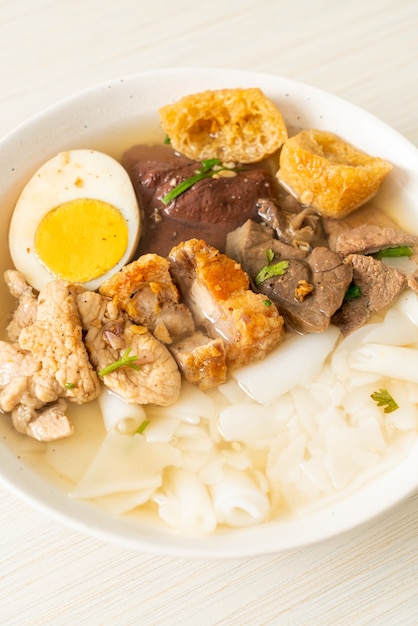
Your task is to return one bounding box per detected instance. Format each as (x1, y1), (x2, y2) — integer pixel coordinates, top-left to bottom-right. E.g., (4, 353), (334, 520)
(35, 198), (128, 283)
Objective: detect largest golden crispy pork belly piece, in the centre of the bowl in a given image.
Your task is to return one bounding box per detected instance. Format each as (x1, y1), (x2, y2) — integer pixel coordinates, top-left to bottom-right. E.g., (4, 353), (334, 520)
(169, 239), (284, 367)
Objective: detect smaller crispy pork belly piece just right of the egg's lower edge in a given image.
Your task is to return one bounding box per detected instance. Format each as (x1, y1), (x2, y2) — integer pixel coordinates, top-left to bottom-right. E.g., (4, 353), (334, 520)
(99, 254), (194, 344)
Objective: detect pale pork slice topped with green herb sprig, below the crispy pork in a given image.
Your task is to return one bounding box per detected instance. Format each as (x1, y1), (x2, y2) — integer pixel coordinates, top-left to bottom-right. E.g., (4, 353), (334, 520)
(77, 291), (181, 406)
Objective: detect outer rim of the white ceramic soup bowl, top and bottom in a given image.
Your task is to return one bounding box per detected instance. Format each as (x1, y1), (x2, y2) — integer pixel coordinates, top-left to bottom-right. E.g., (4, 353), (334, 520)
(0, 67), (418, 559)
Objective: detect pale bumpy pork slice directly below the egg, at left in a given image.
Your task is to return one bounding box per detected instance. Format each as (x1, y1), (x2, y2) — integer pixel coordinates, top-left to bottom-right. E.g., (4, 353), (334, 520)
(18, 280), (101, 404)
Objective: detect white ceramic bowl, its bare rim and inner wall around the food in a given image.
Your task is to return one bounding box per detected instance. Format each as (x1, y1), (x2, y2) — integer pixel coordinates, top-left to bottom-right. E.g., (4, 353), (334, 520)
(0, 68), (418, 558)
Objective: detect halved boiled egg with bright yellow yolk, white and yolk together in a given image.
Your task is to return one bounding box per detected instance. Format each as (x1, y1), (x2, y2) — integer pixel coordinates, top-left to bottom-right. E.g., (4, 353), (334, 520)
(9, 149), (140, 290)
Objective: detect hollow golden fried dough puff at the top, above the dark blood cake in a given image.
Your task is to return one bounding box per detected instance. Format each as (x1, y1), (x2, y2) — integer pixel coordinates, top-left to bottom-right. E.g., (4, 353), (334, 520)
(159, 88), (287, 163)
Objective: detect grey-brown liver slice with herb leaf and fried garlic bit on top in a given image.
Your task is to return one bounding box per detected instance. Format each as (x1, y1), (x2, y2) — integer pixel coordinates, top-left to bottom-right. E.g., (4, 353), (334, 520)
(227, 220), (352, 333)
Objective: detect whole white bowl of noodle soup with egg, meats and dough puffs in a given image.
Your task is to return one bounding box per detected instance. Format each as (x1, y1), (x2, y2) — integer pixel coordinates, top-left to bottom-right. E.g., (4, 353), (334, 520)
(0, 68), (418, 559)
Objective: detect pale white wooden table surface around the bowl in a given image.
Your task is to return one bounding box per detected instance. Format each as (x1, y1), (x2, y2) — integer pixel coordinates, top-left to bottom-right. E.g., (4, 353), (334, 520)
(0, 0), (418, 626)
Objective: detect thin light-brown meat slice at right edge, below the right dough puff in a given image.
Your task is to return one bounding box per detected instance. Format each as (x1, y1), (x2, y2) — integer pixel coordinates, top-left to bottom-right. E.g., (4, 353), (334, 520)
(335, 224), (418, 257)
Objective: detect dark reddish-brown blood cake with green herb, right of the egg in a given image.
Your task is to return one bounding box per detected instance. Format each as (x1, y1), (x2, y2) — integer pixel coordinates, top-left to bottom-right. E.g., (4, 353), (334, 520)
(122, 146), (277, 256)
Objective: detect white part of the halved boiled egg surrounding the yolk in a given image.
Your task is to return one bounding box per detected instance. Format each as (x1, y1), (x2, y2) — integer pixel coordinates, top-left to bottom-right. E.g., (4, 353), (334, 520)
(9, 149), (141, 290)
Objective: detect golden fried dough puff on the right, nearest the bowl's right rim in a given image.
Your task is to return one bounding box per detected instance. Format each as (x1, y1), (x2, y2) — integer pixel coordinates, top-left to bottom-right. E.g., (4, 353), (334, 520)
(277, 130), (392, 218)
